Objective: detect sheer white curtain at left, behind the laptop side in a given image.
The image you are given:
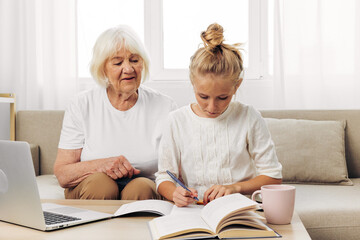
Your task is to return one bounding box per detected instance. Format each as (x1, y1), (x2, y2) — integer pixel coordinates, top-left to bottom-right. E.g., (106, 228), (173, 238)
(0, 0), (77, 110)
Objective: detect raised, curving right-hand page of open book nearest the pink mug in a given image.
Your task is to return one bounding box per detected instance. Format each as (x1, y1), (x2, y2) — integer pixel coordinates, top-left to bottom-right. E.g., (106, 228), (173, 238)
(201, 193), (257, 232)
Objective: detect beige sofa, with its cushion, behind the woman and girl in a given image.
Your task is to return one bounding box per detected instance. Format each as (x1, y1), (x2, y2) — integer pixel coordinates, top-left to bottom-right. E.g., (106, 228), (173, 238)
(16, 110), (360, 240)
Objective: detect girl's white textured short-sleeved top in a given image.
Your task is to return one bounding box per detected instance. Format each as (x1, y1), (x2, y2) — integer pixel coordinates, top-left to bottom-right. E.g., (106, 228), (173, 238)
(155, 102), (282, 198)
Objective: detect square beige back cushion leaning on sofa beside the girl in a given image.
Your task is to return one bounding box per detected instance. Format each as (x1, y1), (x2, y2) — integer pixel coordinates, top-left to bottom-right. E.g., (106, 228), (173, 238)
(265, 118), (352, 185)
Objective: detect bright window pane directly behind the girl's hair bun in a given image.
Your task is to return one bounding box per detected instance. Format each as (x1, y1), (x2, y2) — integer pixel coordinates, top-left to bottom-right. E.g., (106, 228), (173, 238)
(162, 0), (249, 69)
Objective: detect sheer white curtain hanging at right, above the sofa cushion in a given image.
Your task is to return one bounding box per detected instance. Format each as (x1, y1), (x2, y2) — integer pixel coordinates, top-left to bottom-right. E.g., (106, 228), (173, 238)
(274, 0), (360, 109)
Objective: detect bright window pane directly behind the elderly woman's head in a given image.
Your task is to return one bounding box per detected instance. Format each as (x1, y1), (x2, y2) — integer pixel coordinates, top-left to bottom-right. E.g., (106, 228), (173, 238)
(77, 0), (144, 78)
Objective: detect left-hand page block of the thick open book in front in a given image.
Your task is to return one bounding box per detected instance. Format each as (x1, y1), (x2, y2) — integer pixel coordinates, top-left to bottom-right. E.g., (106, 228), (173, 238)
(149, 213), (213, 239)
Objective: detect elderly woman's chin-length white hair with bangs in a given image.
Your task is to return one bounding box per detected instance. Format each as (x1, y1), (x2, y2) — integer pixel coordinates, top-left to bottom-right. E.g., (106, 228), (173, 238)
(90, 25), (150, 87)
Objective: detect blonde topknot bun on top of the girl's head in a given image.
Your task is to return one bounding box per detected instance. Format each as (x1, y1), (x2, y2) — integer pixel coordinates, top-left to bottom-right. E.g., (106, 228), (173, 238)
(200, 23), (224, 52)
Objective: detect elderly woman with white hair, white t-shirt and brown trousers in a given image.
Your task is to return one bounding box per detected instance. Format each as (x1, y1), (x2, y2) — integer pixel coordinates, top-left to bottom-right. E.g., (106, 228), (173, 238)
(54, 26), (176, 200)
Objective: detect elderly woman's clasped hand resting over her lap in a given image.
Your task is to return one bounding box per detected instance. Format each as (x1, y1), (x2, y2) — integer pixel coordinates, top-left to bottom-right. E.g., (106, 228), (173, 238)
(100, 156), (140, 180)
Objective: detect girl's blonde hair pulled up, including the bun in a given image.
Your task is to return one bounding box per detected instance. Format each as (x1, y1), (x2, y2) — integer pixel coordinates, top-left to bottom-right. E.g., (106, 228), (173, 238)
(189, 23), (243, 85)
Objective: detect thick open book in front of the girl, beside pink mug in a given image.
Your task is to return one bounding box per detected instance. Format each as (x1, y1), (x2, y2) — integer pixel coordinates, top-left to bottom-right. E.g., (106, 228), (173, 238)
(149, 193), (281, 239)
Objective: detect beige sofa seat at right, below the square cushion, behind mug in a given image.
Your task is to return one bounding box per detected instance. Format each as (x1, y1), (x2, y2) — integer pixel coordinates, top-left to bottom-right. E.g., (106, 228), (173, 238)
(291, 178), (360, 240)
